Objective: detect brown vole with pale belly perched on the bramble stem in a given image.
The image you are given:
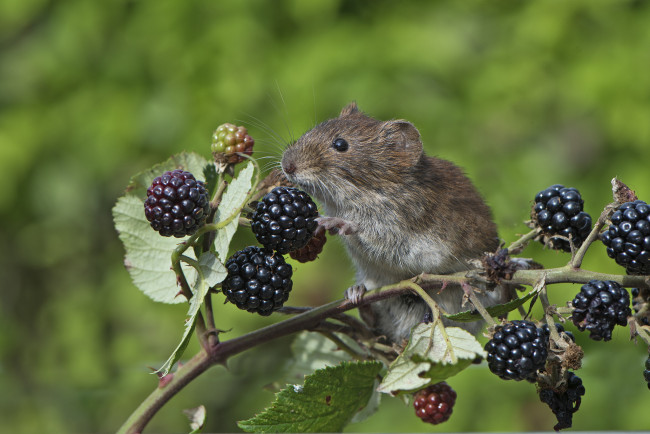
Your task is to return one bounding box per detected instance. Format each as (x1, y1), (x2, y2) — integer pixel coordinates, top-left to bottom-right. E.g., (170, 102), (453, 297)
(282, 103), (504, 343)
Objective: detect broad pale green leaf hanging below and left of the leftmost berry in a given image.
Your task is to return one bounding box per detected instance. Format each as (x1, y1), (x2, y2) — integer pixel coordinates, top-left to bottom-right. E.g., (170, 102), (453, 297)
(113, 194), (196, 303)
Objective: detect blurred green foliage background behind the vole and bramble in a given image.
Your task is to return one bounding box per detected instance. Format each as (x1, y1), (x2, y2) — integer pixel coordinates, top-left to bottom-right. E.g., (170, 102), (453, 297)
(0, 0), (650, 433)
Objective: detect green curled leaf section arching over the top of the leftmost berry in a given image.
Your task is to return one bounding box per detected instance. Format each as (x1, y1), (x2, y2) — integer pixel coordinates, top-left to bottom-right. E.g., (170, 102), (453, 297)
(126, 152), (210, 200)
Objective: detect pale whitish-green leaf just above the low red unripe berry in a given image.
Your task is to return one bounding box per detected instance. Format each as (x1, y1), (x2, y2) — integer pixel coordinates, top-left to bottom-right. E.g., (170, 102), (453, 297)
(378, 321), (484, 395)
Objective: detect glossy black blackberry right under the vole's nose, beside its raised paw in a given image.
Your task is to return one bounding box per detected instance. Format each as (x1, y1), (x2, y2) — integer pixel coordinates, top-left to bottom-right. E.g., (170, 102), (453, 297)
(251, 187), (318, 254)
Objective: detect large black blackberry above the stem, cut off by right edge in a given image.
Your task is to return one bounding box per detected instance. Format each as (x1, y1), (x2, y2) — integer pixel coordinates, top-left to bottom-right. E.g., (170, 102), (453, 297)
(600, 200), (650, 274)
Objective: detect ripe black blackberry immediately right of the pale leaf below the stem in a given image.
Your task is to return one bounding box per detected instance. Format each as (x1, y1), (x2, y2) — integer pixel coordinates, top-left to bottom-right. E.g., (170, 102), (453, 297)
(485, 320), (548, 381)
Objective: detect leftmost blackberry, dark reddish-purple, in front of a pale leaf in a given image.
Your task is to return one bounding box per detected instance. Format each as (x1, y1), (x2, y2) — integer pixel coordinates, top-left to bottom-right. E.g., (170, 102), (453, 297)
(144, 169), (210, 238)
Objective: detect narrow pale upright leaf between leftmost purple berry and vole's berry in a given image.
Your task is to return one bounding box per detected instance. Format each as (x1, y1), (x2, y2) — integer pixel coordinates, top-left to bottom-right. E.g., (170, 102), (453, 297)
(214, 162), (254, 262)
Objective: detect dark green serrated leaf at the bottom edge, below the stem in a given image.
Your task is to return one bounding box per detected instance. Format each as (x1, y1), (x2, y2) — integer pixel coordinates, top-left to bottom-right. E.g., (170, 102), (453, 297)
(238, 362), (382, 433)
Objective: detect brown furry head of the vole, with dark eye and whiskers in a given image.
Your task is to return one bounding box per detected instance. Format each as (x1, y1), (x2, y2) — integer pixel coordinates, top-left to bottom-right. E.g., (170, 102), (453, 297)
(282, 102), (423, 202)
